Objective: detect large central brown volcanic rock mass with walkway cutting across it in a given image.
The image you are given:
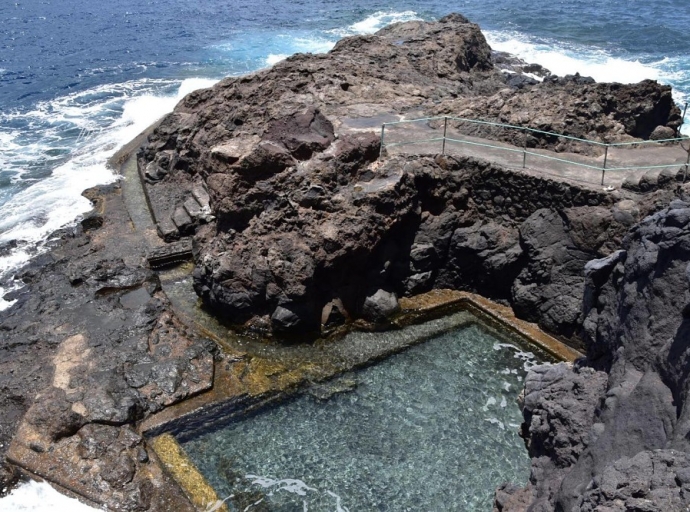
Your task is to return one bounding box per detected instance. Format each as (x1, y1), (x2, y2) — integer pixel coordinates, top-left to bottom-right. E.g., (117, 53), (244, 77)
(139, 15), (679, 337)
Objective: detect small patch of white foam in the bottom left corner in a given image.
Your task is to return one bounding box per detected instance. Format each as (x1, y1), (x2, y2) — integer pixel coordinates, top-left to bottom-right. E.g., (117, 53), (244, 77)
(0, 481), (98, 512)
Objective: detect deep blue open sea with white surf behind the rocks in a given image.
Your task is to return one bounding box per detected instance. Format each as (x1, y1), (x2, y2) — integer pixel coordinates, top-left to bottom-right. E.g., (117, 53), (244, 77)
(0, 0), (690, 308)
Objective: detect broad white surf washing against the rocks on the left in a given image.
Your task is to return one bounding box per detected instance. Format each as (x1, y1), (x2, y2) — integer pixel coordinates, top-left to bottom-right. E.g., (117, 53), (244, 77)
(0, 79), (214, 286)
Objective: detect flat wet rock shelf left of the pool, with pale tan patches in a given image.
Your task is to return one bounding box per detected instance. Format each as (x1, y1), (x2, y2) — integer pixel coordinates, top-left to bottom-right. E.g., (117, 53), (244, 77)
(0, 185), (217, 511)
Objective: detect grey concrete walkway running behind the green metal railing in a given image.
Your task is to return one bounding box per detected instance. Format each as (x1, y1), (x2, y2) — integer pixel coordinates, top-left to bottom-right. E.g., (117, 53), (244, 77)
(342, 116), (690, 189)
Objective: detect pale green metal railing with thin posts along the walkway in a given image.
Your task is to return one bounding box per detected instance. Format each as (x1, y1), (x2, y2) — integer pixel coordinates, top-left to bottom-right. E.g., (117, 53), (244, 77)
(380, 116), (690, 185)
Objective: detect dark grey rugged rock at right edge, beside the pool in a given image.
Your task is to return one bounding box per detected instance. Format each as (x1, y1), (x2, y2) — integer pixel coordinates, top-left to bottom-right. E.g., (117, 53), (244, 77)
(496, 200), (690, 512)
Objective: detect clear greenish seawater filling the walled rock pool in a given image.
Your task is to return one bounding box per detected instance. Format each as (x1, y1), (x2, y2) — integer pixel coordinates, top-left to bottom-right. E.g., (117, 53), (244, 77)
(183, 323), (537, 512)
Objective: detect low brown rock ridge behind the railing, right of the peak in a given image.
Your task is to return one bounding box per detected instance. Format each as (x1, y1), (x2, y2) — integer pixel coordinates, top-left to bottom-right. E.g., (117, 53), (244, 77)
(433, 75), (681, 153)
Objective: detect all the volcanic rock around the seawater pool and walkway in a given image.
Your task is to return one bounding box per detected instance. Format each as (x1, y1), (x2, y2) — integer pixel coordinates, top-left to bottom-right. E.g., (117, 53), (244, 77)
(0, 15), (690, 512)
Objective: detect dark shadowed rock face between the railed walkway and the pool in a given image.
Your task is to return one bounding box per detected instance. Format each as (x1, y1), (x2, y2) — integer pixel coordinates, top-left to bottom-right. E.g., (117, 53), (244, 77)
(189, 150), (660, 340)
